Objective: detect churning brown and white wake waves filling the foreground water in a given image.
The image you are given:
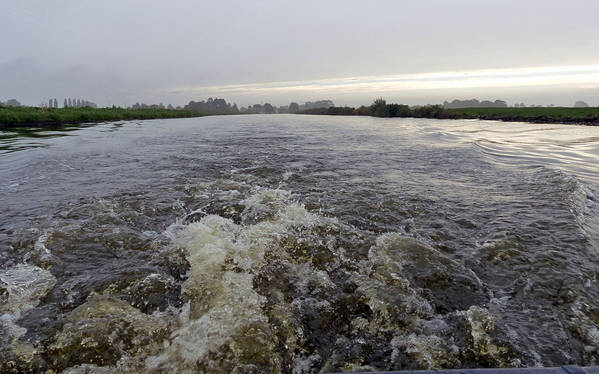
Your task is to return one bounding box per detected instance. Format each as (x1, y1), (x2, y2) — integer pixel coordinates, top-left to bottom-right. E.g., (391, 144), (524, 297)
(3, 186), (524, 373)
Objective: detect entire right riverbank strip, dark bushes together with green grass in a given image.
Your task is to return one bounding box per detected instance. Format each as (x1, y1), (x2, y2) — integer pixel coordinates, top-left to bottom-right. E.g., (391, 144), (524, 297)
(299, 99), (599, 125)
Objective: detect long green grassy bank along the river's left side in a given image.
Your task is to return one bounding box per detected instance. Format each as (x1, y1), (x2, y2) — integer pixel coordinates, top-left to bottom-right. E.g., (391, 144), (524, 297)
(0, 107), (214, 129)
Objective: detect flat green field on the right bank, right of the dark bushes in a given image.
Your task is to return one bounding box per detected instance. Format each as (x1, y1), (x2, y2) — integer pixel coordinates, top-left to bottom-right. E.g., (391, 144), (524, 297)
(446, 107), (599, 125)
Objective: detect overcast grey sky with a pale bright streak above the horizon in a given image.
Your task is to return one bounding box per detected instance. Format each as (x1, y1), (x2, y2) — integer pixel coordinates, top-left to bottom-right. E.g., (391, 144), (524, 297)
(0, 0), (599, 106)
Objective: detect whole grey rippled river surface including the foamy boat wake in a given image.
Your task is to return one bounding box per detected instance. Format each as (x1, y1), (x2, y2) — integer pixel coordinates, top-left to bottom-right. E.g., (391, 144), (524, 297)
(0, 115), (599, 373)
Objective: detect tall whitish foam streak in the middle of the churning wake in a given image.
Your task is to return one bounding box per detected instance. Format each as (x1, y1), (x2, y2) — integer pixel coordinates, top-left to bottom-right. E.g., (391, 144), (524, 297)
(145, 190), (330, 370)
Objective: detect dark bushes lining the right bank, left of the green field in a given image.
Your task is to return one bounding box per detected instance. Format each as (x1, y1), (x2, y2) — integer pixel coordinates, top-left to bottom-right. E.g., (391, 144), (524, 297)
(299, 99), (457, 119)
